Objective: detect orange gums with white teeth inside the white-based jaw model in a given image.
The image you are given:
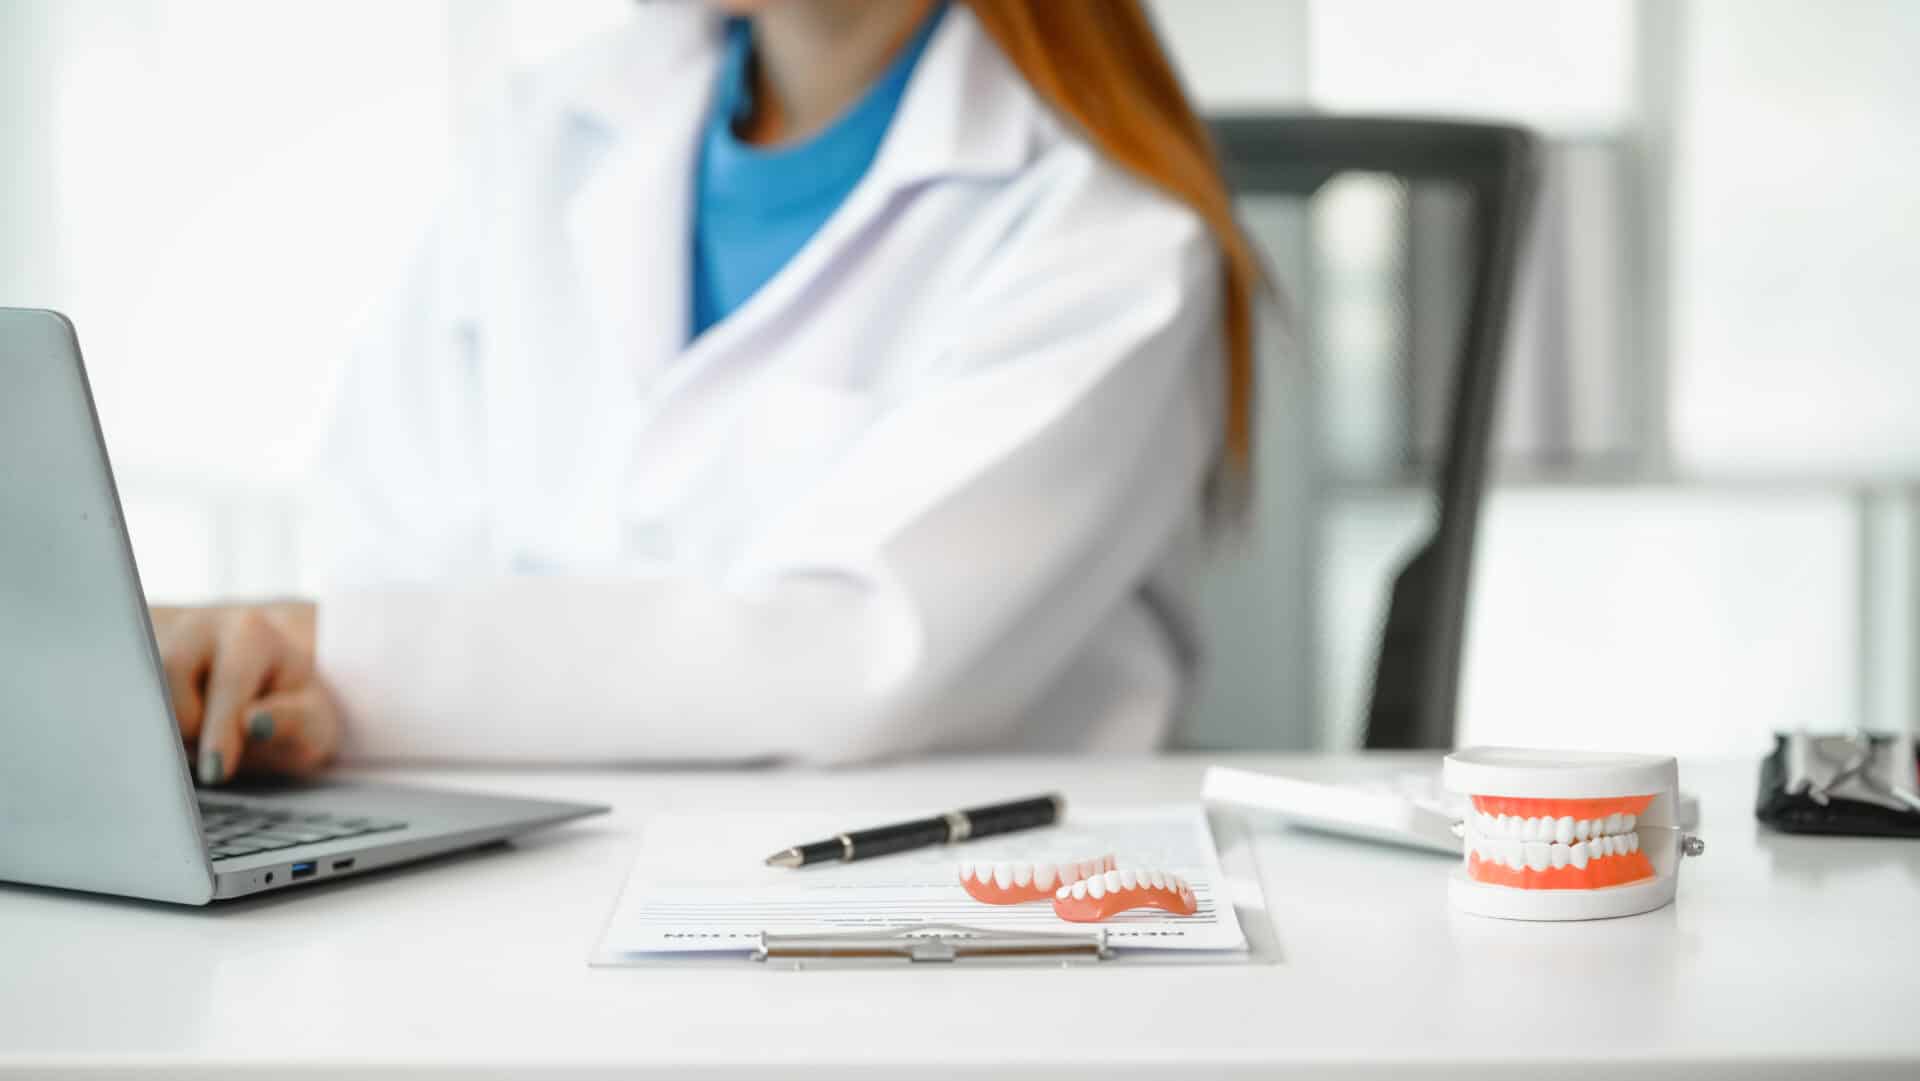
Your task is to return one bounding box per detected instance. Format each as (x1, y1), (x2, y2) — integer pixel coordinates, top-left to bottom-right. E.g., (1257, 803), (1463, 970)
(1467, 795), (1655, 889)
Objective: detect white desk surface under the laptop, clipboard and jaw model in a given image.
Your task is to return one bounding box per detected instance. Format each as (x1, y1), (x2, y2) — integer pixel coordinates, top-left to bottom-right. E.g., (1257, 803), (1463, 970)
(0, 755), (1920, 1081)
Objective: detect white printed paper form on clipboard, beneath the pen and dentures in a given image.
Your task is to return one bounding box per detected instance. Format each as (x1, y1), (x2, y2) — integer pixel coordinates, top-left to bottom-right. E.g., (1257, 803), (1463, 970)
(591, 805), (1248, 964)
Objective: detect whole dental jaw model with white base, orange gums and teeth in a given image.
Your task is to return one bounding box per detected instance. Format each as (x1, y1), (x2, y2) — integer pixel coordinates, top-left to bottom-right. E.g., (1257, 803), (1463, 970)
(1442, 747), (1703, 920)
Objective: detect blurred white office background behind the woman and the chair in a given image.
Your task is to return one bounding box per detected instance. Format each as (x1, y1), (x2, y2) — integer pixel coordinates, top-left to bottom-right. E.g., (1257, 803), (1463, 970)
(0, 0), (1920, 753)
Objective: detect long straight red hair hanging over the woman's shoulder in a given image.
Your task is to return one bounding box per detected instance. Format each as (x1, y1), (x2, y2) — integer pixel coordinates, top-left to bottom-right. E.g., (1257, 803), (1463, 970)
(968, 0), (1265, 474)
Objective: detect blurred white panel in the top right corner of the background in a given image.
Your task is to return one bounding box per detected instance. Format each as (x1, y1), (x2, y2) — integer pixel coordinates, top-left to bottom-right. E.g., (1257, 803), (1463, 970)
(1670, 0), (1920, 478)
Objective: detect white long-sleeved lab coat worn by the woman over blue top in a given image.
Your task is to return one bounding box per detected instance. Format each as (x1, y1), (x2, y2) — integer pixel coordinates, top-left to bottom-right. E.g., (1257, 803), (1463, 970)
(313, 4), (1223, 762)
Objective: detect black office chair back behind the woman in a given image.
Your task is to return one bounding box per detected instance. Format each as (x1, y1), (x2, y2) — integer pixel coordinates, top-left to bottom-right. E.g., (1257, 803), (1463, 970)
(1212, 113), (1538, 749)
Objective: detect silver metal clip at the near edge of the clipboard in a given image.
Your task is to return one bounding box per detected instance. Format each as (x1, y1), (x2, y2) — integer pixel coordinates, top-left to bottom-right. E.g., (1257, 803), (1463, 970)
(753, 924), (1114, 964)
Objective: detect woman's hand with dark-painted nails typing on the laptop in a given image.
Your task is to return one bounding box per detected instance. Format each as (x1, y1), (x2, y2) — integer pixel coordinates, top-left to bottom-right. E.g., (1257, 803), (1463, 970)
(154, 601), (340, 785)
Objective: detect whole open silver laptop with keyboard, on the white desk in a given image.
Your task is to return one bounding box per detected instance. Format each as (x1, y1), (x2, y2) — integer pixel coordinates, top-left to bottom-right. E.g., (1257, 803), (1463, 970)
(0, 309), (607, 904)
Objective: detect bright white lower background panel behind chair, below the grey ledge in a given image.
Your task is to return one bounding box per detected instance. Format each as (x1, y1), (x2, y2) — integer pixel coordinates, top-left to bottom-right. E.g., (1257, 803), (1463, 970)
(1317, 486), (1860, 753)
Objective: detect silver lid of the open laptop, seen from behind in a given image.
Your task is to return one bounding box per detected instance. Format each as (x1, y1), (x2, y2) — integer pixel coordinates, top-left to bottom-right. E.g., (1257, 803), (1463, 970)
(0, 309), (213, 904)
